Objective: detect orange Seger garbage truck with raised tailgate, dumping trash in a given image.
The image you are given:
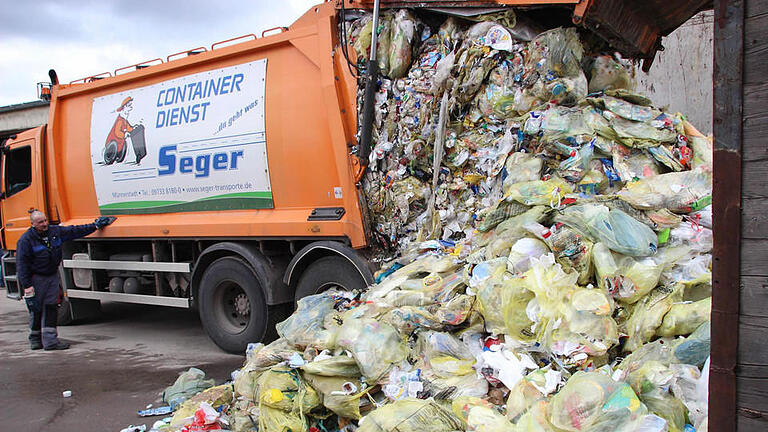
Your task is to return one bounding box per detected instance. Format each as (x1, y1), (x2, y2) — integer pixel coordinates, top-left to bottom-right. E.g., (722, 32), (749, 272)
(0, 0), (698, 352)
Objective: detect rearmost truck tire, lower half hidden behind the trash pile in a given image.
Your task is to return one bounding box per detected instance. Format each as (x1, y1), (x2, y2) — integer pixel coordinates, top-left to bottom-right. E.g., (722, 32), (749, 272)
(295, 256), (367, 302)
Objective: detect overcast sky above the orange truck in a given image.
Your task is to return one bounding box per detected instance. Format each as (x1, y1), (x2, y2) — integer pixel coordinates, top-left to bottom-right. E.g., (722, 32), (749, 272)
(0, 0), (322, 106)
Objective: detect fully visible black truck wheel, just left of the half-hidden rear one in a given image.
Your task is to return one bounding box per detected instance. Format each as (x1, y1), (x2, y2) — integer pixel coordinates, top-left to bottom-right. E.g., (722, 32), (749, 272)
(198, 257), (269, 354)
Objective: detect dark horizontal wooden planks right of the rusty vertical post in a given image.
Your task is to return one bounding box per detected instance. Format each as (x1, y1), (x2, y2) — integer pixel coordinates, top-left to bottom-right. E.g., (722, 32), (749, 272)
(736, 0), (768, 431)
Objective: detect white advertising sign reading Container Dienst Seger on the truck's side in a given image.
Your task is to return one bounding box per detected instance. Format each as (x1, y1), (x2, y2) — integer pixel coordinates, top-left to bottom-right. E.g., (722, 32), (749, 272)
(91, 59), (273, 215)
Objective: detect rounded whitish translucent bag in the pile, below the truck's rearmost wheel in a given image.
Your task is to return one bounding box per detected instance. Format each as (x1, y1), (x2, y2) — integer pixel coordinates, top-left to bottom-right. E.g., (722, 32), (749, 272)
(337, 318), (408, 383)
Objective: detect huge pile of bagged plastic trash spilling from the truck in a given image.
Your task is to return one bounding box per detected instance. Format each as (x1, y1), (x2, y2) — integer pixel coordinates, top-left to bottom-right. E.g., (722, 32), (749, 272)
(134, 6), (712, 432)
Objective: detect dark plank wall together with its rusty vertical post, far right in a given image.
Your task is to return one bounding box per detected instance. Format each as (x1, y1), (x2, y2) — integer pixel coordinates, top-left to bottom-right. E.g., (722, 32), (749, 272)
(709, 0), (768, 431)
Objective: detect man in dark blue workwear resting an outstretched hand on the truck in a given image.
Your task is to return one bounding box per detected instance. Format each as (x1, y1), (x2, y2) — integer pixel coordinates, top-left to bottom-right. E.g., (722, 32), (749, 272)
(16, 210), (114, 350)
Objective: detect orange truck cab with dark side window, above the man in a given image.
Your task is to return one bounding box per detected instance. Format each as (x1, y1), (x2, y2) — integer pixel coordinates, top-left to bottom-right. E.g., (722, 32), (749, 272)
(0, 126), (46, 250)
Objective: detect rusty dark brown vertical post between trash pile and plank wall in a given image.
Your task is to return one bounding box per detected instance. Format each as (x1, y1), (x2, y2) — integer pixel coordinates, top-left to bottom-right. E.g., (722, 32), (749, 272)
(709, 0), (744, 431)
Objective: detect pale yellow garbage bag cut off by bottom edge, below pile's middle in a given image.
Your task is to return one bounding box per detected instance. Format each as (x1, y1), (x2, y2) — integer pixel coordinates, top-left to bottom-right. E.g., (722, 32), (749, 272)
(357, 399), (462, 432)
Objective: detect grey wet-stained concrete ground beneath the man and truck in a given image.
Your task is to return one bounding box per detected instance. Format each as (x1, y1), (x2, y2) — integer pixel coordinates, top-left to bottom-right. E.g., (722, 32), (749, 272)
(0, 289), (245, 432)
